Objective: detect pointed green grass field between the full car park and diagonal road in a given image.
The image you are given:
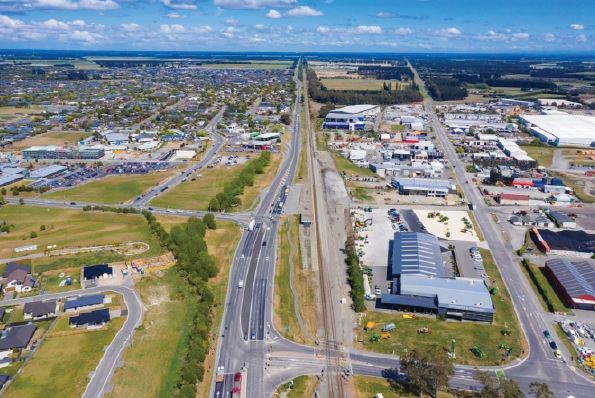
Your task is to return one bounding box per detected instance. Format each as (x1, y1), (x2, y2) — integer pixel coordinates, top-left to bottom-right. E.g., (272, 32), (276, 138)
(42, 170), (174, 204)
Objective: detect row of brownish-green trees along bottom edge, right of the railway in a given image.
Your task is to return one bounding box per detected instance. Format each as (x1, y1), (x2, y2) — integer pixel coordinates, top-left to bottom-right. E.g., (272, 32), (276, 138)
(400, 345), (554, 398)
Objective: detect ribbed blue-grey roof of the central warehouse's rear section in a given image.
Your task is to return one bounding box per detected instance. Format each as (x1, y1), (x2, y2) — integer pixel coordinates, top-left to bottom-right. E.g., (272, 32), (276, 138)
(391, 232), (444, 277)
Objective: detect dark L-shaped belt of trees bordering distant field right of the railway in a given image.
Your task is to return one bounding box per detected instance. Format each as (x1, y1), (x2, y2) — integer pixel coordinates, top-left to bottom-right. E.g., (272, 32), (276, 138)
(307, 69), (422, 105)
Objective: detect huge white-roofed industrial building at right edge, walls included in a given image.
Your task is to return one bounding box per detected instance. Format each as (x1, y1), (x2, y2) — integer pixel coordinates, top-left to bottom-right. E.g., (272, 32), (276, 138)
(520, 111), (595, 147)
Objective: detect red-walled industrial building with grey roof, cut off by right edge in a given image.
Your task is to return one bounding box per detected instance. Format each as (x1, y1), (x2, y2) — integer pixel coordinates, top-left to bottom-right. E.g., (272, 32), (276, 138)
(545, 258), (595, 310)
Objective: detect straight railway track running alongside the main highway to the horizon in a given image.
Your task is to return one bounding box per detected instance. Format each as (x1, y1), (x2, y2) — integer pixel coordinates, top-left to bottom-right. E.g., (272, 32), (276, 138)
(303, 67), (345, 398)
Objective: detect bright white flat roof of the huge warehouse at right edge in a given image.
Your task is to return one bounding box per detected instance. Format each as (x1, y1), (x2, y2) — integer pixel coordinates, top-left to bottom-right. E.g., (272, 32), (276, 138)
(521, 114), (595, 146)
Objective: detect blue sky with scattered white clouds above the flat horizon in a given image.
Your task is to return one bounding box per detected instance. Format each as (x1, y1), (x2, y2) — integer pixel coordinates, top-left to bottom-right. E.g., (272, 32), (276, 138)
(0, 0), (595, 53)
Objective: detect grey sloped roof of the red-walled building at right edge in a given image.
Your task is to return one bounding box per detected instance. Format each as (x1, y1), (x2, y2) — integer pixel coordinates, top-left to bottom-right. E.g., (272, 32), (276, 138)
(545, 258), (595, 301)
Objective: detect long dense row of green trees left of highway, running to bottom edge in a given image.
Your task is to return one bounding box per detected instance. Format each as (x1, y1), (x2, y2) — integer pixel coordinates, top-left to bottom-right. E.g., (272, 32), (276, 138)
(143, 210), (219, 398)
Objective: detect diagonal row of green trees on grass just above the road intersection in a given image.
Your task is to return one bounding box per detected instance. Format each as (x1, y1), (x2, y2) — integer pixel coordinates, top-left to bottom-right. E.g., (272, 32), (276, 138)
(209, 151), (271, 211)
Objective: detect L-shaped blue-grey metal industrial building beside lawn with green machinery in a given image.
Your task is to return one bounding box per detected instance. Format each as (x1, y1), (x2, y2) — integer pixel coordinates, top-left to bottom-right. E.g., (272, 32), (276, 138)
(380, 232), (494, 322)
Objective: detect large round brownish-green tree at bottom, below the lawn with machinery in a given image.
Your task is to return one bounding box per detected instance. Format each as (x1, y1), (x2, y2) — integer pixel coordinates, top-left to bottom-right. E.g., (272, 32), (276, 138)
(401, 345), (454, 397)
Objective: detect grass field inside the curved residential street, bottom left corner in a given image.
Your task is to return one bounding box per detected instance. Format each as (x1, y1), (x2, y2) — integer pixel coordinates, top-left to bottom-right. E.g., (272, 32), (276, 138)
(3, 317), (125, 398)
